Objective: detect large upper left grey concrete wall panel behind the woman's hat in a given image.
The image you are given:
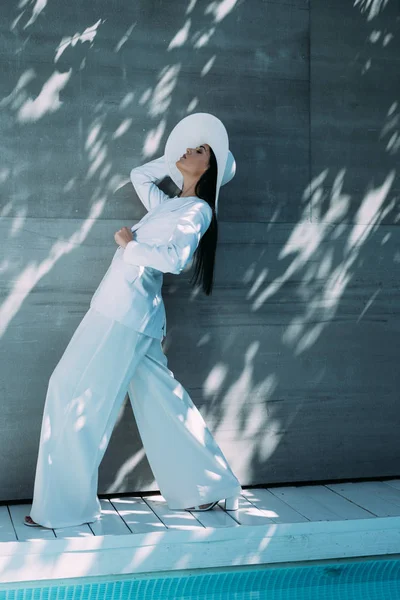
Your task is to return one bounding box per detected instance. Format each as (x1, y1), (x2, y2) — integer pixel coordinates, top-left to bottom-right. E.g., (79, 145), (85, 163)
(2, 2), (308, 221)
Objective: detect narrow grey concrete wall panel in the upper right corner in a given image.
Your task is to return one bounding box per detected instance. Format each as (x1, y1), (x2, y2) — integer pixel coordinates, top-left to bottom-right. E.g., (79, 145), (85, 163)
(310, 1), (400, 224)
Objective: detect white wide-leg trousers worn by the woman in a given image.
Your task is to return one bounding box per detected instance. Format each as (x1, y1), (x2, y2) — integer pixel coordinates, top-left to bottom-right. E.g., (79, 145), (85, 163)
(30, 308), (242, 528)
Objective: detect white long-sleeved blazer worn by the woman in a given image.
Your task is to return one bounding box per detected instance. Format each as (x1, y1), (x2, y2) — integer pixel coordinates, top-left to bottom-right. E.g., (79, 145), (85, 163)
(90, 156), (212, 339)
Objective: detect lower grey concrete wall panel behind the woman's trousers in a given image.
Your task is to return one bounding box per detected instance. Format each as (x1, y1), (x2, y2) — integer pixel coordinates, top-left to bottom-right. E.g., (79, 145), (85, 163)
(1, 211), (400, 497)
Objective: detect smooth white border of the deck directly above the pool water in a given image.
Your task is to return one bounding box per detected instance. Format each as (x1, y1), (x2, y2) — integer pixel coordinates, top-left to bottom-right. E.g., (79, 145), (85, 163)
(0, 517), (400, 589)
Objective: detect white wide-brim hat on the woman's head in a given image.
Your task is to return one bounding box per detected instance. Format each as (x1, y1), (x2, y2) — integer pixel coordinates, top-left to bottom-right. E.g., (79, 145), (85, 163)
(164, 113), (236, 214)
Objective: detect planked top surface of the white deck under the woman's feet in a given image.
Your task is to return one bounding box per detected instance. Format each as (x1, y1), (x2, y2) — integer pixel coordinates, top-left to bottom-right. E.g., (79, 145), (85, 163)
(0, 478), (400, 542)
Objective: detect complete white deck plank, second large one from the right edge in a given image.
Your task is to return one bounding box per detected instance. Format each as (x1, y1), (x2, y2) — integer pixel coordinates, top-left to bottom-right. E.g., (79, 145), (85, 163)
(269, 485), (373, 521)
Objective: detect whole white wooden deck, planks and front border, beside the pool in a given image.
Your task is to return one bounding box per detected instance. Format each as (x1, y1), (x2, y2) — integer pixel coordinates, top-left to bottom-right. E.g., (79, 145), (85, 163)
(0, 479), (400, 587)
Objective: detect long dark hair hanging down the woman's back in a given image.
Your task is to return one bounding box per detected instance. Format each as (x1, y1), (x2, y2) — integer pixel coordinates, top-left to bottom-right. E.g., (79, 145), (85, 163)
(190, 147), (218, 296)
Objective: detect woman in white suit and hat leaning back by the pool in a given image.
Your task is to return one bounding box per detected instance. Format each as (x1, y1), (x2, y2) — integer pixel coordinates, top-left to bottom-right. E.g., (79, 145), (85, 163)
(24, 113), (242, 528)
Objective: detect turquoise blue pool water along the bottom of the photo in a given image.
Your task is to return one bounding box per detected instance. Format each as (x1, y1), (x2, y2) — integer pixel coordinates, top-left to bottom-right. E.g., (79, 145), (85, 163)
(0, 559), (400, 600)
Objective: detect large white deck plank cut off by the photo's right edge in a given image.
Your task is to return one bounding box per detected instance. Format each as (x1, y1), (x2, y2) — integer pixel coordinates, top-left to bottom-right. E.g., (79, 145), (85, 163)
(326, 481), (400, 517)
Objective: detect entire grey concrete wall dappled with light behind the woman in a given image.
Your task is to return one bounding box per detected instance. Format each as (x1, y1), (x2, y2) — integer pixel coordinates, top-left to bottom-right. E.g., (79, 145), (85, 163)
(0, 0), (400, 500)
